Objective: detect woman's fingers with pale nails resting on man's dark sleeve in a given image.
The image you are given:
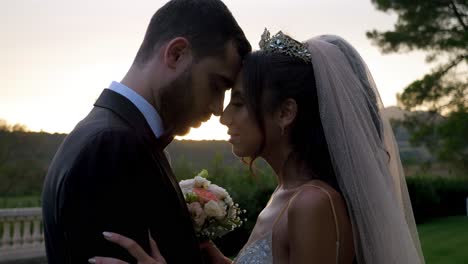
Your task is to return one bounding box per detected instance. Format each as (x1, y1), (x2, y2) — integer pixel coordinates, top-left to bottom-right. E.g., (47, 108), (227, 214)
(88, 232), (167, 264)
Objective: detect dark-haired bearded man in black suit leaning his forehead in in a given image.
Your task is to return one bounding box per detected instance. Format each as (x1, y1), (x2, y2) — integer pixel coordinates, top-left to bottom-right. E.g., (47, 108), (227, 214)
(42, 0), (251, 264)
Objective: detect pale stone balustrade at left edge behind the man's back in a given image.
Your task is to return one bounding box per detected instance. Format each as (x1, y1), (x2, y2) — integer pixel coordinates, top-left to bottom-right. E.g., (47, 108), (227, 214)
(0, 207), (45, 262)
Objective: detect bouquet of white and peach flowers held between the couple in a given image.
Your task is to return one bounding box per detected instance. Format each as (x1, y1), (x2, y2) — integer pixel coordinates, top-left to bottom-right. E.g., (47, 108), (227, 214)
(179, 170), (245, 239)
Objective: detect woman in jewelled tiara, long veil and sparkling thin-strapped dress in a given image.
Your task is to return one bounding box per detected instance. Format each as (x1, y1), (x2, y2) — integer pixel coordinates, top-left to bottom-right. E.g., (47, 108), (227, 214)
(90, 30), (424, 264)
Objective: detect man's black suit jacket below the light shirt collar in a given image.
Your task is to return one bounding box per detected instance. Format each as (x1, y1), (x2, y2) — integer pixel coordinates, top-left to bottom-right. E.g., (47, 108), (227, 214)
(42, 89), (203, 264)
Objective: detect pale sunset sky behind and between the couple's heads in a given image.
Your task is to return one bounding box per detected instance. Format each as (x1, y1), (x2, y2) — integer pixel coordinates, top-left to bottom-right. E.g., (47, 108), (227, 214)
(0, 0), (431, 139)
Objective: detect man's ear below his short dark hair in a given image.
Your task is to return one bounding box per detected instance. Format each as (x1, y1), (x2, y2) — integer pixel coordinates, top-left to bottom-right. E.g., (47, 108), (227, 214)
(164, 37), (192, 69)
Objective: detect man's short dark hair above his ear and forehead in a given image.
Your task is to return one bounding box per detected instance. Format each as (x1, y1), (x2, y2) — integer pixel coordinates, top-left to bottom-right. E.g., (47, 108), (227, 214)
(135, 0), (252, 64)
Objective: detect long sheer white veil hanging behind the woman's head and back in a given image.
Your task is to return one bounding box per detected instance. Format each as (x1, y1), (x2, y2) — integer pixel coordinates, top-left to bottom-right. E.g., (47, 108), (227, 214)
(306, 35), (424, 264)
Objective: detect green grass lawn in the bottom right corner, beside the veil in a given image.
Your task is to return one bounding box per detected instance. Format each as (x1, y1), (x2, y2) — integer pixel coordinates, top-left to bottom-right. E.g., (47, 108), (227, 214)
(418, 216), (468, 264)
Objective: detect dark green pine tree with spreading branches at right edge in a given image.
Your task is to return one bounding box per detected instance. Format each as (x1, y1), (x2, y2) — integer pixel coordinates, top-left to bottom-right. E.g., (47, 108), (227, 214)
(366, 0), (468, 172)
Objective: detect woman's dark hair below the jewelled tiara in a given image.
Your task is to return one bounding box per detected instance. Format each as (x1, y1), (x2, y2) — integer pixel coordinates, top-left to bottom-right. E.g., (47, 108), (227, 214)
(242, 51), (339, 191)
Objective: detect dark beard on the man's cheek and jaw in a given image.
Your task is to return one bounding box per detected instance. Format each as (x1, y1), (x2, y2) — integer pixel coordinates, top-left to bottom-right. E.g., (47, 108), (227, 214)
(159, 67), (195, 135)
